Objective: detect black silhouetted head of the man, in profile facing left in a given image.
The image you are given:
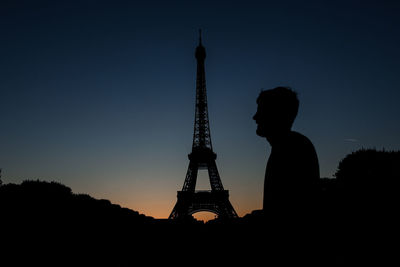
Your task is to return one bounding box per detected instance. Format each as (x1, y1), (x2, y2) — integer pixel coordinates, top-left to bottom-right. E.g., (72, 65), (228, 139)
(253, 87), (299, 142)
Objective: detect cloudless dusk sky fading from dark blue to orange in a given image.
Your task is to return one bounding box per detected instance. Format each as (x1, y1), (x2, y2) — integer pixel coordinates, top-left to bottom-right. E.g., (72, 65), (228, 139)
(0, 0), (400, 221)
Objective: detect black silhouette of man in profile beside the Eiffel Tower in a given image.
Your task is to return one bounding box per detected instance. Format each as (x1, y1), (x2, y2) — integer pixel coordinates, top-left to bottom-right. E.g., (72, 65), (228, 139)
(253, 87), (319, 219)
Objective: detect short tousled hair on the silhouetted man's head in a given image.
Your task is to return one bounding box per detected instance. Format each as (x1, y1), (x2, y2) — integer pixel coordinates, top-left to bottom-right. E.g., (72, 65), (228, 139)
(257, 87), (299, 126)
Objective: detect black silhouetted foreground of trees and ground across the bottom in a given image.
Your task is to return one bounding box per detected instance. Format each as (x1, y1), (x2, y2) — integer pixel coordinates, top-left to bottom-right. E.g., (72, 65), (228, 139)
(0, 150), (400, 266)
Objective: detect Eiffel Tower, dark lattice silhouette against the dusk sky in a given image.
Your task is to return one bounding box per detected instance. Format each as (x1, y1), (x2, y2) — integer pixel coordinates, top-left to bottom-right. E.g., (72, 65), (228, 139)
(169, 30), (238, 219)
